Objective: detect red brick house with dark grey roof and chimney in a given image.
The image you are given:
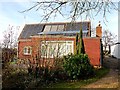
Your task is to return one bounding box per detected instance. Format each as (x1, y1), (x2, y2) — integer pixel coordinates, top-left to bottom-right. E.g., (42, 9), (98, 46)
(18, 21), (102, 66)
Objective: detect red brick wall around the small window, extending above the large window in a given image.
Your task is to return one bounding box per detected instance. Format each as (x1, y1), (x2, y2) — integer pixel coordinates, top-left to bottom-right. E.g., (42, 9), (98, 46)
(18, 36), (76, 61)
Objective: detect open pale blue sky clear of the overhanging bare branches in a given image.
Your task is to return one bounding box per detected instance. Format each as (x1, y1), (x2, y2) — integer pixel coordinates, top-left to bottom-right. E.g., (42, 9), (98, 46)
(0, 0), (118, 41)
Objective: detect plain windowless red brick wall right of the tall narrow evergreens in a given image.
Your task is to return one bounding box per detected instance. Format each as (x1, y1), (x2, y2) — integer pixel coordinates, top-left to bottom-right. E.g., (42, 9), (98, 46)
(83, 38), (101, 66)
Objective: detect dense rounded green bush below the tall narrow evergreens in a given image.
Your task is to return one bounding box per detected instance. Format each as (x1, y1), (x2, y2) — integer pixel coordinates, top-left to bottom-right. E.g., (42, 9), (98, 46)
(63, 54), (94, 79)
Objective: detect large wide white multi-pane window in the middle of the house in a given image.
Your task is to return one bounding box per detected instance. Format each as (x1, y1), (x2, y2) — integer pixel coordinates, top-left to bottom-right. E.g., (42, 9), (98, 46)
(41, 41), (74, 58)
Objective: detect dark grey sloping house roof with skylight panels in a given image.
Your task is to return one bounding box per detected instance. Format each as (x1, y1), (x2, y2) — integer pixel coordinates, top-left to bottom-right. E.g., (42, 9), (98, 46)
(19, 22), (90, 39)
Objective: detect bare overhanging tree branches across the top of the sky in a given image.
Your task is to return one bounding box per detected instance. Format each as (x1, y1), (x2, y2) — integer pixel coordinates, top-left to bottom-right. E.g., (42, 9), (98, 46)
(22, 0), (118, 21)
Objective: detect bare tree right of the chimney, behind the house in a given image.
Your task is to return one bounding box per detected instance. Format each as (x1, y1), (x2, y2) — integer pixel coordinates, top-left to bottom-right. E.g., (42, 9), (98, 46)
(102, 30), (117, 53)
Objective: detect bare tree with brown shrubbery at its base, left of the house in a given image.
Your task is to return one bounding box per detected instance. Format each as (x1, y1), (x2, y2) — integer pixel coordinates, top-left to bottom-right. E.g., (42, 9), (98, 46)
(1, 25), (19, 62)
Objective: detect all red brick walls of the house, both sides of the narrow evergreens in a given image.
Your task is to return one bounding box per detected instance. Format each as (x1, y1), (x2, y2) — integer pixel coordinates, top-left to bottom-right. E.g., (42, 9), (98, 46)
(18, 36), (100, 66)
